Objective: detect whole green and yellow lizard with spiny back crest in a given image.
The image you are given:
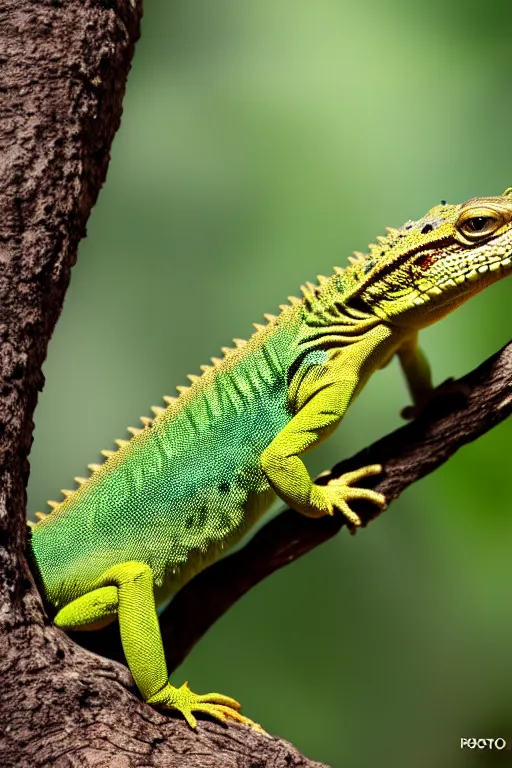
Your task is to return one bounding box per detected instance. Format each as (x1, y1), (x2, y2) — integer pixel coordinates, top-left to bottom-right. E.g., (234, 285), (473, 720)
(30, 190), (512, 727)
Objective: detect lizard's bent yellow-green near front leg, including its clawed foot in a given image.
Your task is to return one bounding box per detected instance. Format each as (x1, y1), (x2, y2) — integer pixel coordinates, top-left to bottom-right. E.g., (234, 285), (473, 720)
(261, 376), (386, 526)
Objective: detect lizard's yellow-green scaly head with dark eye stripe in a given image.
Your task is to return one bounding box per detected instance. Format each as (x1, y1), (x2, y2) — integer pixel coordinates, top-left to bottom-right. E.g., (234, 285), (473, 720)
(338, 189), (512, 328)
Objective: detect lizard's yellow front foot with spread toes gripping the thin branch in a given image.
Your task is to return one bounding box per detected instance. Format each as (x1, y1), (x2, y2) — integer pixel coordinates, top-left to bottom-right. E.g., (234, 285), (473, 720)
(314, 464), (386, 532)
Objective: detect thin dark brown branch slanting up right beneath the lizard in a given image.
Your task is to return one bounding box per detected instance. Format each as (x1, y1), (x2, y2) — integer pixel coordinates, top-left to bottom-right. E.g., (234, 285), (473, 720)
(77, 343), (512, 670)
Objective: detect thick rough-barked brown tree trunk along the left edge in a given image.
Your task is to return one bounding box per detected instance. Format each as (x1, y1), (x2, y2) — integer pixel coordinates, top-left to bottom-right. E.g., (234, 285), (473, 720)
(0, 0), (328, 768)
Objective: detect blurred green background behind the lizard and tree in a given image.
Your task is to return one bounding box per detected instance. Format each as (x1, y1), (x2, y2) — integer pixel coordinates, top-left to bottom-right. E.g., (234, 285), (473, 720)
(29, 0), (512, 768)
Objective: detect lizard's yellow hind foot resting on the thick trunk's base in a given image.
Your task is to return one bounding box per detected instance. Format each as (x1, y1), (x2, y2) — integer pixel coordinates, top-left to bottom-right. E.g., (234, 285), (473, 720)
(147, 683), (263, 730)
